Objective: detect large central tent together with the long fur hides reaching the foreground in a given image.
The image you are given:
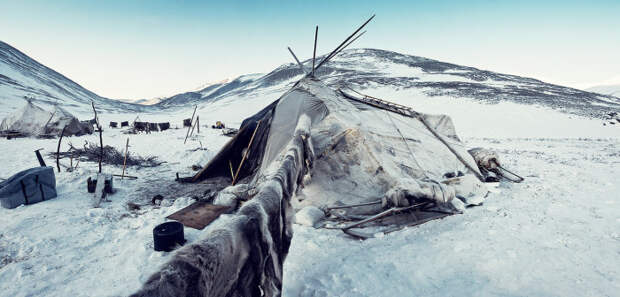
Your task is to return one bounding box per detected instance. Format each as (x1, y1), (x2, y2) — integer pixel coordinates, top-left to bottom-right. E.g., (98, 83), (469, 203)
(133, 77), (494, 296)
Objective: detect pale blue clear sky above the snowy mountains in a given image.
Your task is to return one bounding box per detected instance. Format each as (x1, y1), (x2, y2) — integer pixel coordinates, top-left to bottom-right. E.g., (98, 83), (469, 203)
(0, 0), (620, 99)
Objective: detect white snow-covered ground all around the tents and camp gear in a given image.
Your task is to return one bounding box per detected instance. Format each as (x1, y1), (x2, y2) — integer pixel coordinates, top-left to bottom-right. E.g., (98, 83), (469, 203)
(0, 87), (620, 296)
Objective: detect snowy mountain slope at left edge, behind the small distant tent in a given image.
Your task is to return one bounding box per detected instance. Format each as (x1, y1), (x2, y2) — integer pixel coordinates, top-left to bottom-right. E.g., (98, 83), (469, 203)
(0, 41), (143, 116)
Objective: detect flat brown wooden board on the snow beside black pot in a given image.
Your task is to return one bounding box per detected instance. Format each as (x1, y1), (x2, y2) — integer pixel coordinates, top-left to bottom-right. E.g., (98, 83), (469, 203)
(166, 201), (230, 230)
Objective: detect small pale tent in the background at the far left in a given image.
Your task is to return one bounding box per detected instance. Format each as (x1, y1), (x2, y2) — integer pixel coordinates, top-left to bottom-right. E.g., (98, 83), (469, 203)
(0, 101), (93, 136)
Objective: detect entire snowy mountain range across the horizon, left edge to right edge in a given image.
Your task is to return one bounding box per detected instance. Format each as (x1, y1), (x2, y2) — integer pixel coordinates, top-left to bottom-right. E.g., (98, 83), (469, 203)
(0, 41), (620, 118)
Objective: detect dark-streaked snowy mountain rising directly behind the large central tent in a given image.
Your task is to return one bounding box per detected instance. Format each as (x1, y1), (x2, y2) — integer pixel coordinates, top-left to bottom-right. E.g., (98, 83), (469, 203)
(157, 49), (620, 118)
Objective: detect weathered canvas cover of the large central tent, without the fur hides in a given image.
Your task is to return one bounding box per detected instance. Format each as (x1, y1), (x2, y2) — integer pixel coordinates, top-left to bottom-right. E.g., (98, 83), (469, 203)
(192, 78), (487, 207)
